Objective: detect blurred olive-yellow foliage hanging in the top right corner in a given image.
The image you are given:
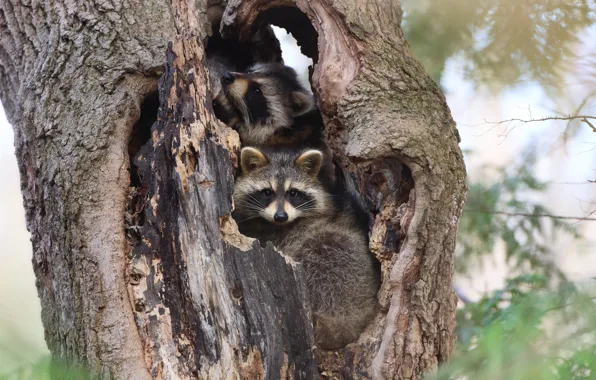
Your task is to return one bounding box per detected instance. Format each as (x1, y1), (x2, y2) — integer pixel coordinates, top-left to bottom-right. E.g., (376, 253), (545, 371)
(402, 0), (596, 87)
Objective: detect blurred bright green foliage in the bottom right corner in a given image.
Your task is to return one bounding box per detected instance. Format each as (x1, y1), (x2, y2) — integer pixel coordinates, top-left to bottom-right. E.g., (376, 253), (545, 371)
(433, 275), (596, 380)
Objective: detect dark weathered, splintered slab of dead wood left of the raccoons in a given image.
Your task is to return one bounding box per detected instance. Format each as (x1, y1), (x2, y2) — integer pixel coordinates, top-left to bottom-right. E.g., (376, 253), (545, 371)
(128, 35), (317, 379)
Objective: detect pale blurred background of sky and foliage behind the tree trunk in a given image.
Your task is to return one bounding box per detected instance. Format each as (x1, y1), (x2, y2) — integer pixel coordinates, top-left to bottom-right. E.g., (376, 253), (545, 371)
(0, 0), (596, 379)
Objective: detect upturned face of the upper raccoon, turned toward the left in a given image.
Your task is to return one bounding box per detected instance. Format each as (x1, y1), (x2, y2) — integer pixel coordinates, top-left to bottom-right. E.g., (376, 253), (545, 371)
(221, 64), (314, 139)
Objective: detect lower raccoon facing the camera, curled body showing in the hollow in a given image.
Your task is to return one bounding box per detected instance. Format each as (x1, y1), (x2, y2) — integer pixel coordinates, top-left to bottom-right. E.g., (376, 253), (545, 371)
(234, 147), (380, 350)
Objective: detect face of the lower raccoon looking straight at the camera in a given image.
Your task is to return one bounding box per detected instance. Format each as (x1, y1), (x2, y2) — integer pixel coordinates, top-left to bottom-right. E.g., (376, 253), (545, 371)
(234, 148), (332, 225)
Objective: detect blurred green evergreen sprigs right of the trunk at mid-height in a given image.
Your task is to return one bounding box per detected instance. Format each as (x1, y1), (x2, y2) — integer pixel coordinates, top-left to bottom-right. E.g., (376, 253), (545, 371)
(456, 153), (579, 278)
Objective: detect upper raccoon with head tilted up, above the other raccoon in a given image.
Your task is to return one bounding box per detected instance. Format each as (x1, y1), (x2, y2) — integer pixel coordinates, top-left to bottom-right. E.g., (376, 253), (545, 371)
(221, 63), (324, 148)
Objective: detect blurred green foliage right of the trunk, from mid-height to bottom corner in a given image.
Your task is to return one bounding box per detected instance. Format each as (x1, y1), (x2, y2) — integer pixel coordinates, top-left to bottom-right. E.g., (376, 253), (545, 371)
(450, 145), (596, 380)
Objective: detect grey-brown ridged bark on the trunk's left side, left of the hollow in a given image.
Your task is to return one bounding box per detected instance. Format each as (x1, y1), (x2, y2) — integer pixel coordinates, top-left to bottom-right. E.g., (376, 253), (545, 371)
(0, 0), (175, 378)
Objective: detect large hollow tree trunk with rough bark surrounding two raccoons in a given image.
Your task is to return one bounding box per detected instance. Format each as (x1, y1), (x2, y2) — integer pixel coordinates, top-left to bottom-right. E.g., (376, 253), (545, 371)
(0, 0), (466, 379)
